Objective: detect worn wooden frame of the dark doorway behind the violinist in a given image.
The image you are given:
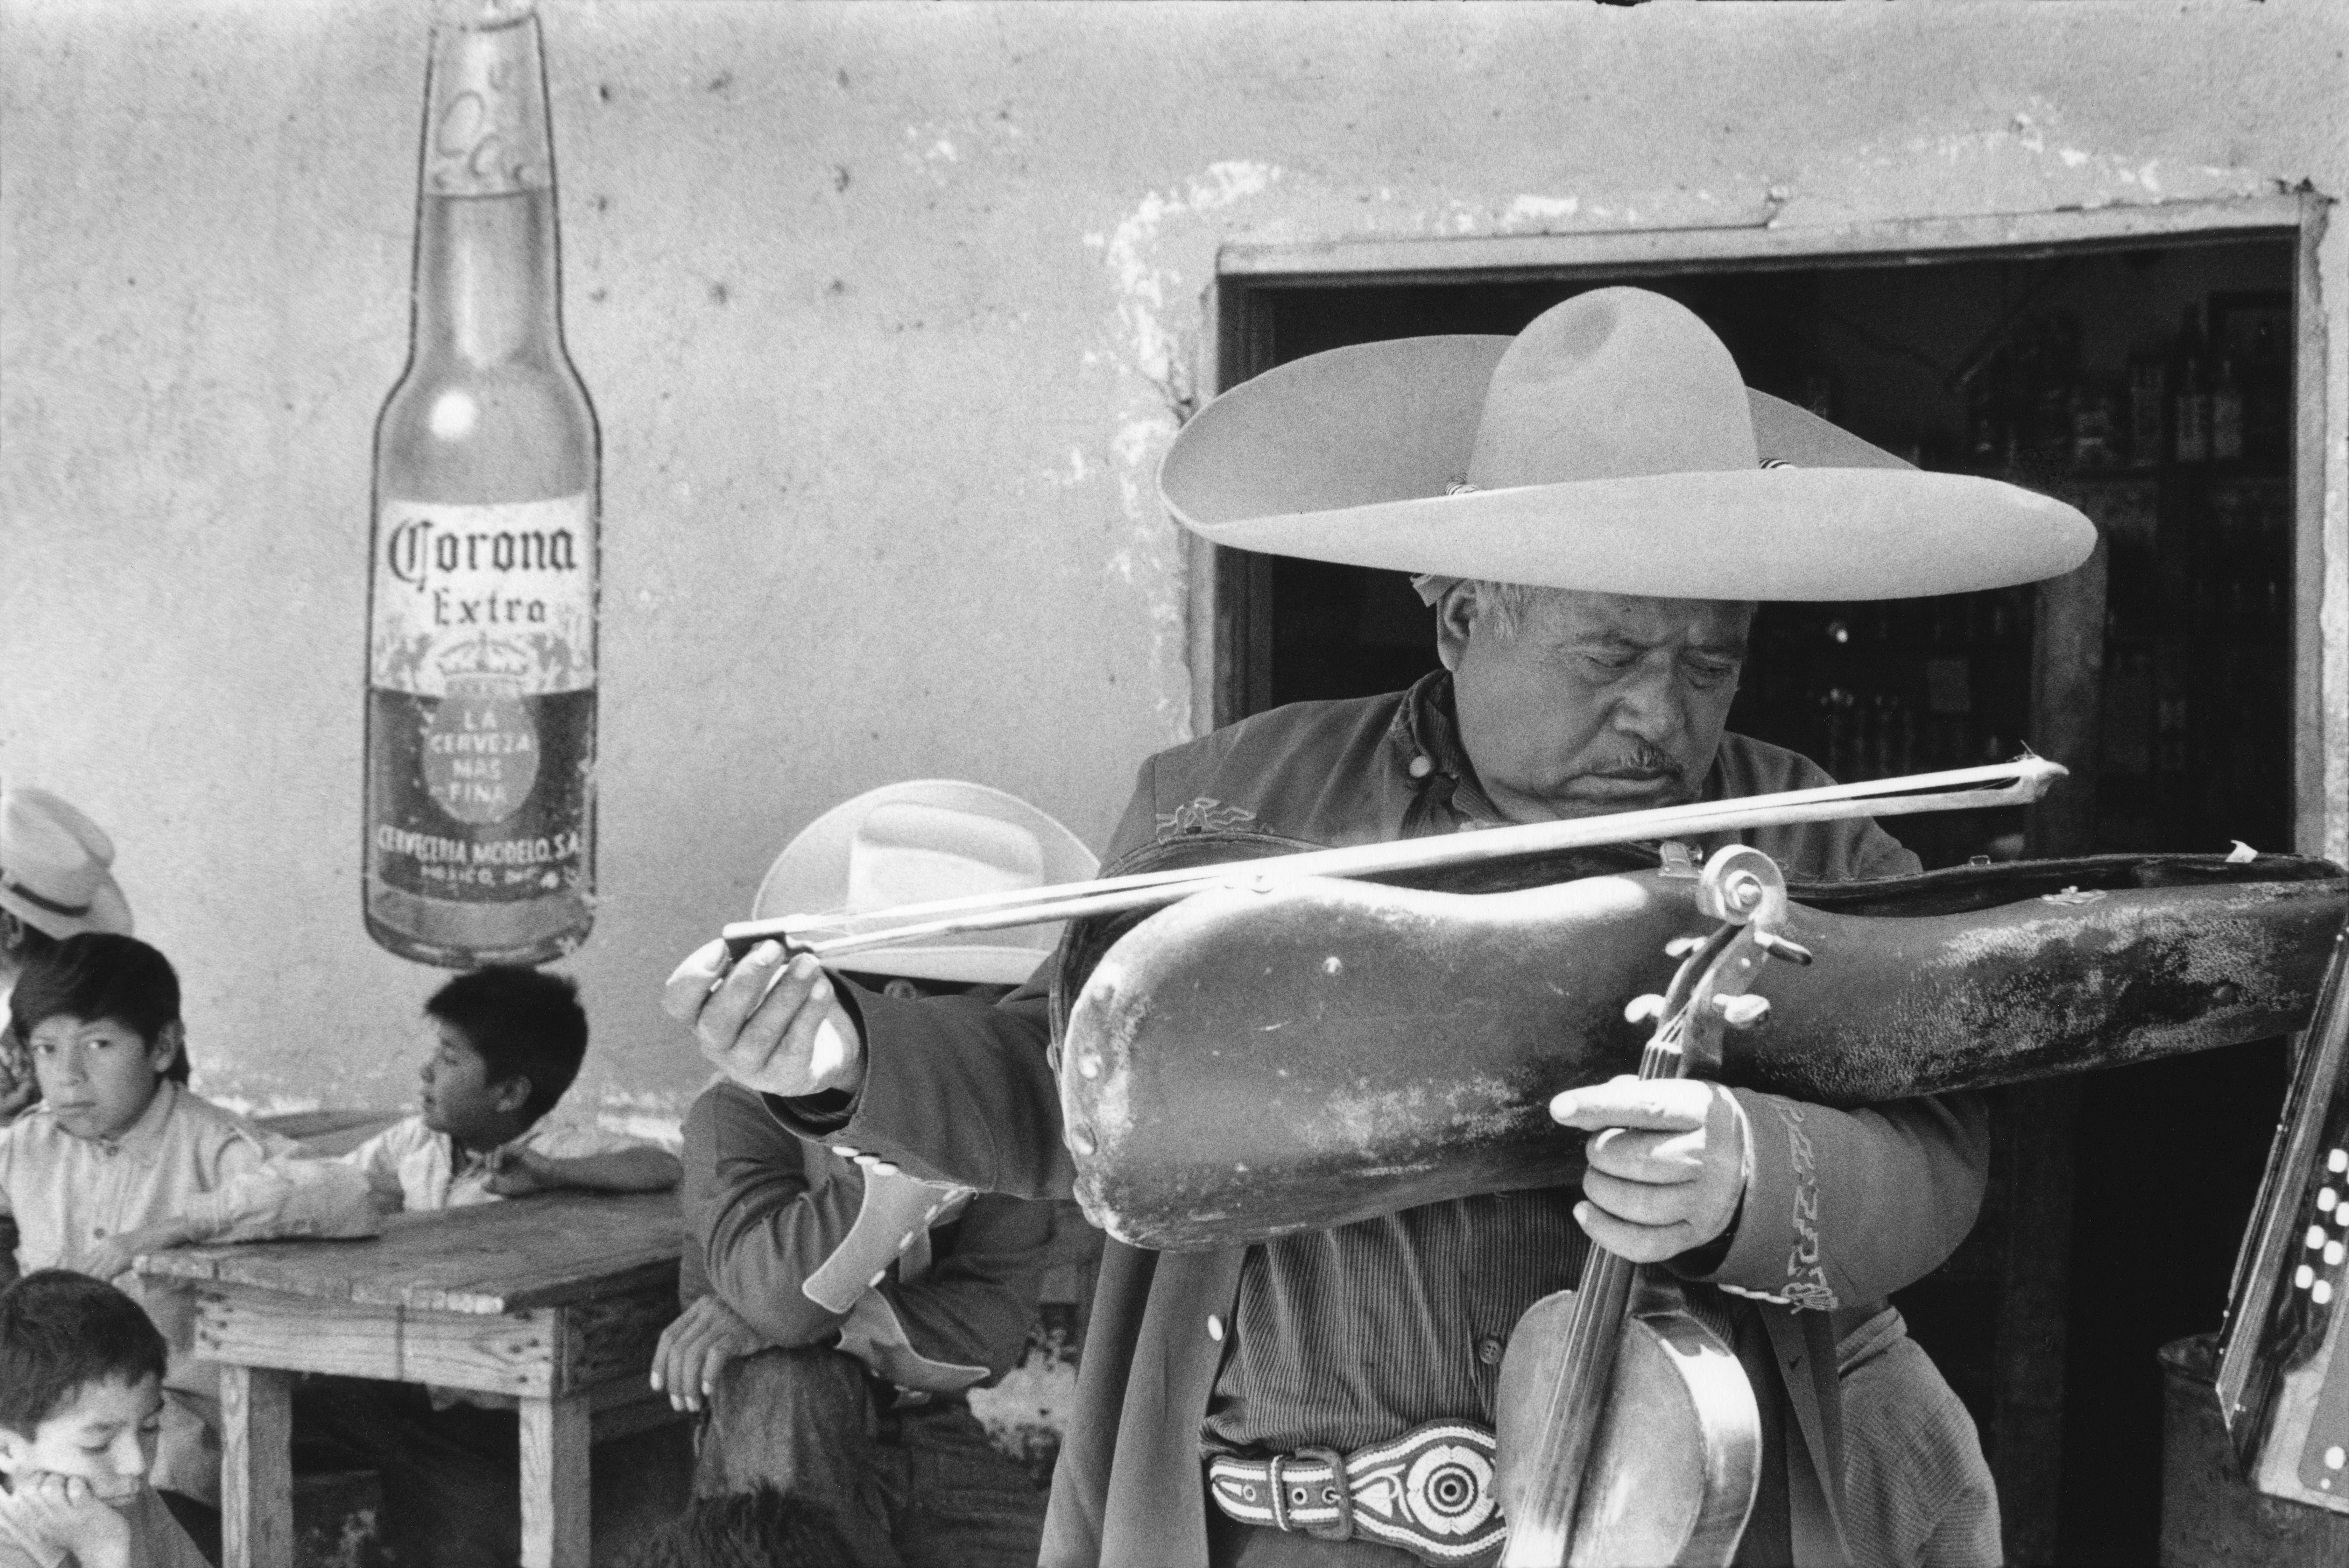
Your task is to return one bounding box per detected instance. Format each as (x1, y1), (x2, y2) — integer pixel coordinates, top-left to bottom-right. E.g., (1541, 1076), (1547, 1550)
(1184, 192), (2349, 857)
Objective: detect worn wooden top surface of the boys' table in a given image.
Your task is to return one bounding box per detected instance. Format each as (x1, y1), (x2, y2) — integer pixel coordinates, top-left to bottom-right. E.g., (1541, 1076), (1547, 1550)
(139, 1192), (684, 1314)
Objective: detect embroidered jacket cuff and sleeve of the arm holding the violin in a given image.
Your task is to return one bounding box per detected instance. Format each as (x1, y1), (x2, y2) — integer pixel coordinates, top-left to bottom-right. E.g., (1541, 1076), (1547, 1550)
(1691, 1089), (1990, 1310)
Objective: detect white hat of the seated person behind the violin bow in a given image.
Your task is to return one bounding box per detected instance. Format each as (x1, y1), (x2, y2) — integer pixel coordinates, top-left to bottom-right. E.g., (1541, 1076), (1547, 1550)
(752, 779), (1099, 986)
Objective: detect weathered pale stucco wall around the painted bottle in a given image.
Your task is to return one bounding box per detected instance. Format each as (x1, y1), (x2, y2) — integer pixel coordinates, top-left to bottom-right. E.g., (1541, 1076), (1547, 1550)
(0, 0), (2349, 1117)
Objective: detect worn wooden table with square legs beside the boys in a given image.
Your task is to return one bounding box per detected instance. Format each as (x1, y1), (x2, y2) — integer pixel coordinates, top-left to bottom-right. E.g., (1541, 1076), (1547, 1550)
(139, 1192), (684, 1568)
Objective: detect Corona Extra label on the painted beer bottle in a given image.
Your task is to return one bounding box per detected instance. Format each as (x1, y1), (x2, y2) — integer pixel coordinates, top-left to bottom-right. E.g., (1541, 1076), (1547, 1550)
(366, 495), (594, 904)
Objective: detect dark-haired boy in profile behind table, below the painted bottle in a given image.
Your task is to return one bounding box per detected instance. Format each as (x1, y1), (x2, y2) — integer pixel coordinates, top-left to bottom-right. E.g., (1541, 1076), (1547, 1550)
(343, 965), (679, 1209)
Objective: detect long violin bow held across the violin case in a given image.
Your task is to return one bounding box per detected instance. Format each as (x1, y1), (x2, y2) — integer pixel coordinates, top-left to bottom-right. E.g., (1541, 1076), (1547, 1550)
(721, 753), (2065, 963)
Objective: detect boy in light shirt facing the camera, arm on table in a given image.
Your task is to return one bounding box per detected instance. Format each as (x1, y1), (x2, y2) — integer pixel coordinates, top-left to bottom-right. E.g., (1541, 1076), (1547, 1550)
(0, 932), (378, 1507)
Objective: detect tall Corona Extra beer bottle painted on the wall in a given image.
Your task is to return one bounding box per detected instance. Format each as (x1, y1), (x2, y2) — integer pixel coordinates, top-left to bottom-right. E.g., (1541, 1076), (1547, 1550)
(364, 0), (599, 967)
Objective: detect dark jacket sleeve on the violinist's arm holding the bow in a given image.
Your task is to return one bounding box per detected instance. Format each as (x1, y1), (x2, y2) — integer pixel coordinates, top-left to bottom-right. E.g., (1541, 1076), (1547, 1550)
(766, 763), (1158, 1197)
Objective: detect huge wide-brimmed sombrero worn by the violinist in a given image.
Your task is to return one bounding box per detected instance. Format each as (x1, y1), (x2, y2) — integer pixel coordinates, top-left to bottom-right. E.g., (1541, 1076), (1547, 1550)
(1158, 289), (2095, 598)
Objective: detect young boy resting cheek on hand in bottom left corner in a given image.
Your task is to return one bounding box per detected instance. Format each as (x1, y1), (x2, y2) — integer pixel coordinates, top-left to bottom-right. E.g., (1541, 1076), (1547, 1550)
(0, 1270), (204, 1568)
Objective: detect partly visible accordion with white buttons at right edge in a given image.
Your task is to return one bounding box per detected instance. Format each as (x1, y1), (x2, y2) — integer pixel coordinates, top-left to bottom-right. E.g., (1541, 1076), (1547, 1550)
(2217, 932), (2349, 1514)
